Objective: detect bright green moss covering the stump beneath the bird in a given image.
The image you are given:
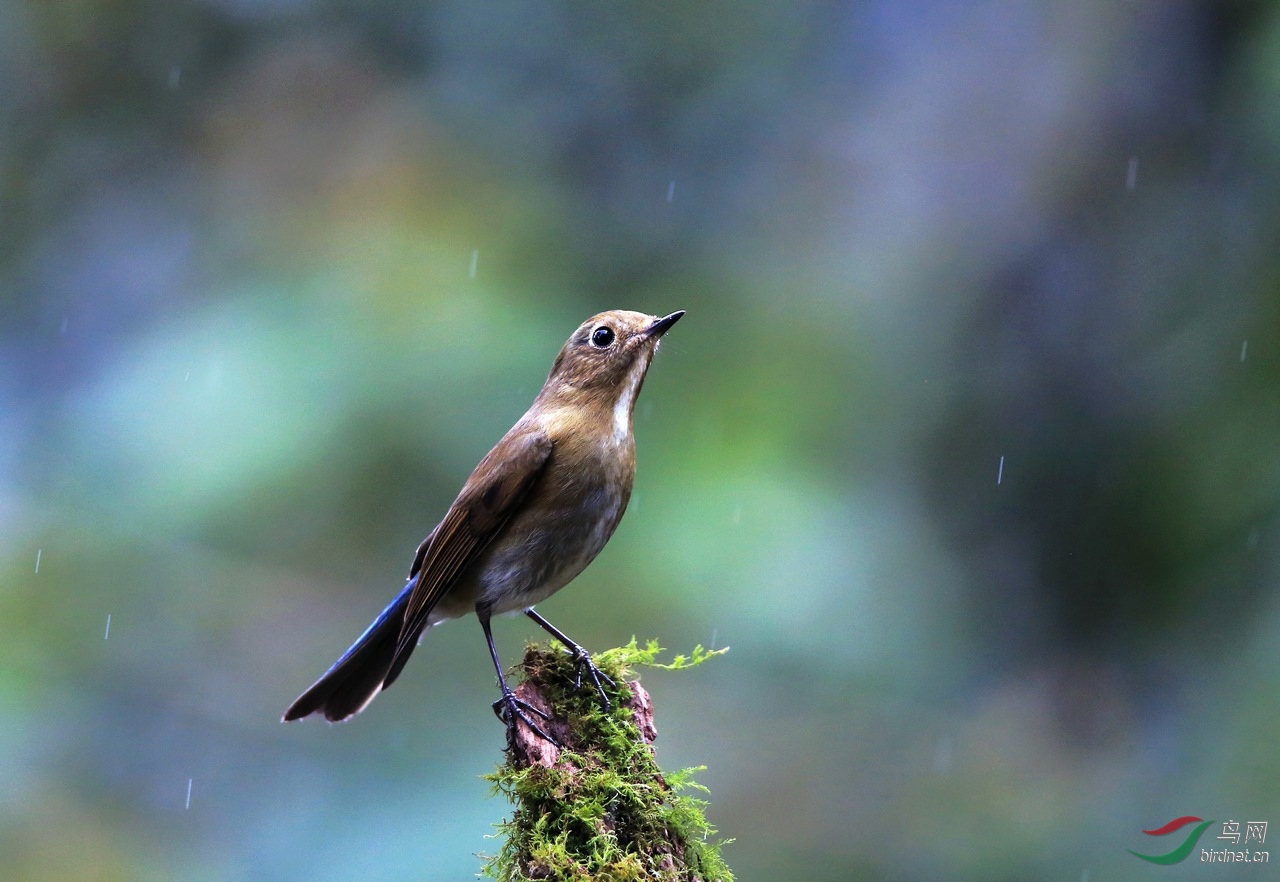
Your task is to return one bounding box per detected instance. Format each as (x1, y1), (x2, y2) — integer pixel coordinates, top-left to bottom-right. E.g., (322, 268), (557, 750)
(484, 637), (733, 882)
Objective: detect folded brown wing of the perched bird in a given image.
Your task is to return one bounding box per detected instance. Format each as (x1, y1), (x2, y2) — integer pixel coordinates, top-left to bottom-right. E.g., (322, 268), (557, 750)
(396, 430), (552, 655)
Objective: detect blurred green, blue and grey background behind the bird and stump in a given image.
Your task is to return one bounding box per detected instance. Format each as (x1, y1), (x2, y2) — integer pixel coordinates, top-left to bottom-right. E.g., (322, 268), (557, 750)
(0, 0), (1280, 882)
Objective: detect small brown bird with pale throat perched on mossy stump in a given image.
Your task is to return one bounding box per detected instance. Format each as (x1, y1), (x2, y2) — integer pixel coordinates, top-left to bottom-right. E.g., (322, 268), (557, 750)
(284, 310), (684, 740)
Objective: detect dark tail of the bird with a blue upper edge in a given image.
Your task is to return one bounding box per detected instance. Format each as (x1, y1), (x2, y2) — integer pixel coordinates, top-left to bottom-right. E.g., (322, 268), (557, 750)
(283, 580), (419, 722)
